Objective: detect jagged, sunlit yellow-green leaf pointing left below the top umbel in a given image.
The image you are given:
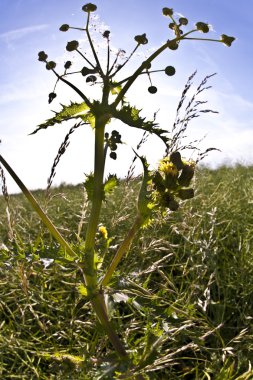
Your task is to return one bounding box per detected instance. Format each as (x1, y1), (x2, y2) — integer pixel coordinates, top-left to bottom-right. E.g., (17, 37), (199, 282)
(31, 102), (91, 135)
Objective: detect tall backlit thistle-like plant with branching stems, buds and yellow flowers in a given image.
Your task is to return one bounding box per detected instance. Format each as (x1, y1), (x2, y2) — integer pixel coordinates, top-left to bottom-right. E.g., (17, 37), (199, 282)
(0, 3), (235, 378)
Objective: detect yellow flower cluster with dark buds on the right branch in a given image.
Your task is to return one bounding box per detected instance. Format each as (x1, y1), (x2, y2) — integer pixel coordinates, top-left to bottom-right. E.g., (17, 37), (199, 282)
(152, 152), (195, 211)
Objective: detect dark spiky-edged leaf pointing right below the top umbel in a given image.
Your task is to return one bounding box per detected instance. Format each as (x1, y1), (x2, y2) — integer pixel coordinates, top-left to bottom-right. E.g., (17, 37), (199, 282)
(111, 105), (168, 146)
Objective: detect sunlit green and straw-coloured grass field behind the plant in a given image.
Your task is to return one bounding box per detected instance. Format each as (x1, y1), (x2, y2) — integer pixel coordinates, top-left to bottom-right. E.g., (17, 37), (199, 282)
(0, 165), (253, 380)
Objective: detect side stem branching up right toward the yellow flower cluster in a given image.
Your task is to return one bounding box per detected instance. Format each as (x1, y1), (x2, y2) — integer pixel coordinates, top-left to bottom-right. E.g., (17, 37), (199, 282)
(101, 217), (141, 286)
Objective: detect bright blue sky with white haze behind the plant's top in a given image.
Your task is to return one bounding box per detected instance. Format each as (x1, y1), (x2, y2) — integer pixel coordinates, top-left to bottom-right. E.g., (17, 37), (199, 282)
(0, 0), (253, 191)
